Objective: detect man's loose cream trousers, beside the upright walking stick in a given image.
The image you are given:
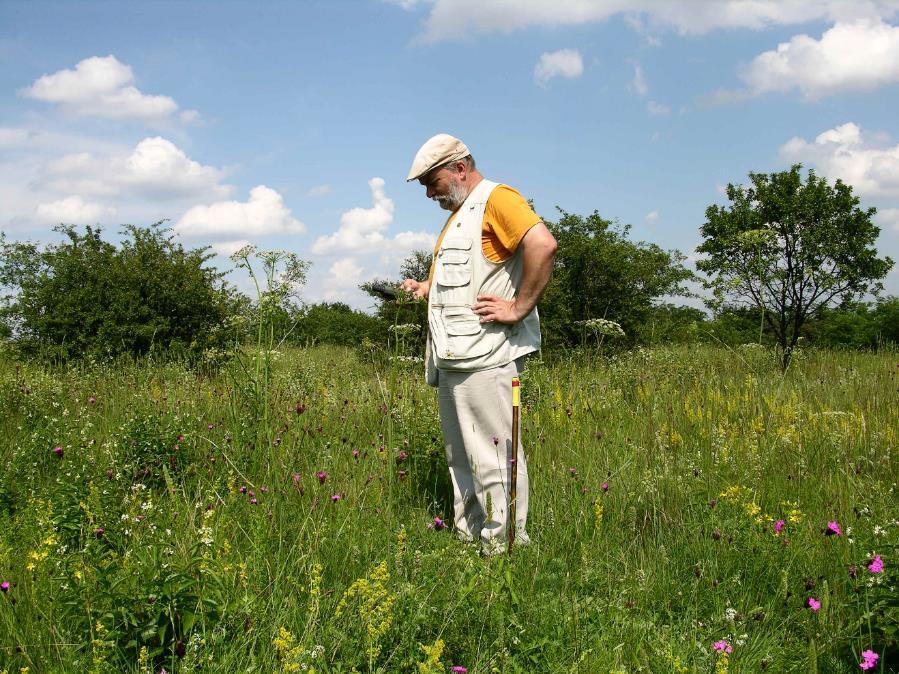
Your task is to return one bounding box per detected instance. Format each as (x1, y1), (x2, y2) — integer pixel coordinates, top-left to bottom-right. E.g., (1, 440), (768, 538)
(438, 358), (528, 554)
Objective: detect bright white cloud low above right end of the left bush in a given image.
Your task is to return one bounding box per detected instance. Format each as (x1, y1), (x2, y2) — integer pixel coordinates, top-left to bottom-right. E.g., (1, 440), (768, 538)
(175, 185), (306, 238)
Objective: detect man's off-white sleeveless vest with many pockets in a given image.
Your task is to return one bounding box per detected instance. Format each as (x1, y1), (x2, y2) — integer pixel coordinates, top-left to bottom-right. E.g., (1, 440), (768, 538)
(428, 180), (540, 371)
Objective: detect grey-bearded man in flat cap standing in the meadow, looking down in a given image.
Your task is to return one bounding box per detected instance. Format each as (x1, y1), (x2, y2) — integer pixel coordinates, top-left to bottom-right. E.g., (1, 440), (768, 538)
(402, 134), (556, 554)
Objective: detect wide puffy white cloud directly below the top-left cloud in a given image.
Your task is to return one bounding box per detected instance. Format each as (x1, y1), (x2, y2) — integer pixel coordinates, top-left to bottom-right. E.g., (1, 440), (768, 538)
(43, 136), (230, 198)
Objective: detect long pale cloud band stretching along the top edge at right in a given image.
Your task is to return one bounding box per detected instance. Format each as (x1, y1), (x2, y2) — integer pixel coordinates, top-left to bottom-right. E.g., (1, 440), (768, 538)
(405, 0), (899, 42)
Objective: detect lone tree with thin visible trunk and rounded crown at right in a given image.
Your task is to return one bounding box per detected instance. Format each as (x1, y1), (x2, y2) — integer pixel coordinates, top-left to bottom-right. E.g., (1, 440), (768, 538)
(696, 164), (893, 369)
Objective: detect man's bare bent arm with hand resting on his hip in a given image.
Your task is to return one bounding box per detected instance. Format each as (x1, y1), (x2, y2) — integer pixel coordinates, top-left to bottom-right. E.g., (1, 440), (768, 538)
(471, 222), (557, 323)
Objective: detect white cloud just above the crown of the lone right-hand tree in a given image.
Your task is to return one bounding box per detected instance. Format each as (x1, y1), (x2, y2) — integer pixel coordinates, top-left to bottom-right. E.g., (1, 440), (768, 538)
(780, 122), (899, 198)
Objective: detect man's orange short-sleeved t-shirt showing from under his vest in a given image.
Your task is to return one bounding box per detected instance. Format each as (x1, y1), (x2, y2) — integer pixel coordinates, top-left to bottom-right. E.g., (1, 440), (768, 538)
(431, 185), (541, 276)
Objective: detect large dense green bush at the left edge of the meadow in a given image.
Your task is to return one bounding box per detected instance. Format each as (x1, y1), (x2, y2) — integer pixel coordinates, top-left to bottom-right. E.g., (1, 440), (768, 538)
(0, 223), (236, 358)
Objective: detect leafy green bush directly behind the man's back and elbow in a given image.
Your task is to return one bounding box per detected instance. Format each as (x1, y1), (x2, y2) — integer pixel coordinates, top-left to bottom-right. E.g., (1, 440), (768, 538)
(539, 209), (693, 346)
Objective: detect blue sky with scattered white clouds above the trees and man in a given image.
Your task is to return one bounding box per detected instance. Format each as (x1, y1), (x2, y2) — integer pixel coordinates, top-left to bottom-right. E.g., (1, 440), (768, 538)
(0, 0), (899, 308)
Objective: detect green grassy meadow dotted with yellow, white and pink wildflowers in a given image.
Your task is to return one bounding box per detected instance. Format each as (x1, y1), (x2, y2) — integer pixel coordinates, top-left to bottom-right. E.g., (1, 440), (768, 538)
(0, 345), (899, 674)
